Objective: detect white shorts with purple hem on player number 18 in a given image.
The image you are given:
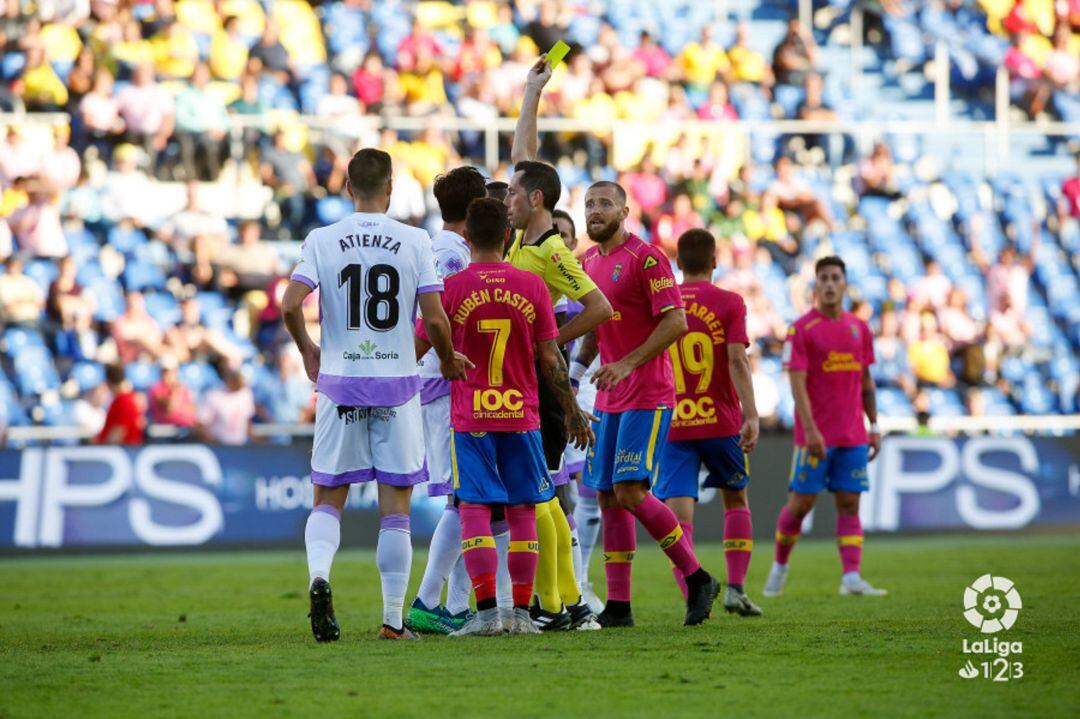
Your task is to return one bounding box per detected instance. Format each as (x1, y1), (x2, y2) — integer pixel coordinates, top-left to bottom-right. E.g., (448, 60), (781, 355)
(311, 392), (428, 487)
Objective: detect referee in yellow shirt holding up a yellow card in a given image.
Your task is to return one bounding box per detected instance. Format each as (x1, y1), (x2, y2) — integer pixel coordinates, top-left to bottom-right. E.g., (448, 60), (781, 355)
(505, 57), (611, 630)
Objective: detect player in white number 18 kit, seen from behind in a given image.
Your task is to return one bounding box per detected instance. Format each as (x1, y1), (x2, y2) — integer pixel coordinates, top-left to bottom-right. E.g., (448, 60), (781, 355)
(282, 148), (469, 641)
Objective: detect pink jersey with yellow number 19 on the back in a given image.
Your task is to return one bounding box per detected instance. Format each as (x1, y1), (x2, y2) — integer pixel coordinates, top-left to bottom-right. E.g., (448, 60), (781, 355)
(667, 282), (750, 439)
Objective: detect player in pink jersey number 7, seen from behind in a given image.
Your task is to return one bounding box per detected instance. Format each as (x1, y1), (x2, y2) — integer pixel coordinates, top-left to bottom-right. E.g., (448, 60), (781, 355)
(418, 199), (592, 636)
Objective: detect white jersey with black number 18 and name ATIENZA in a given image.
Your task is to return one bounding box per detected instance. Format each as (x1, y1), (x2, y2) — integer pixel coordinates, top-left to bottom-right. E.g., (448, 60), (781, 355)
(292, 213), (443, 407)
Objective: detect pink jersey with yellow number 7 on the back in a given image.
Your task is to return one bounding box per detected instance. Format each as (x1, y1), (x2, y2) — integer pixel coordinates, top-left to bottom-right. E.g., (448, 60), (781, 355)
(417, 262), (558, 432)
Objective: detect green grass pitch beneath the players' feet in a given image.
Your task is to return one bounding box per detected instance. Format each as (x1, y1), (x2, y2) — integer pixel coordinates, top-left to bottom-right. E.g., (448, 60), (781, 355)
(0, 534), (1080, 719)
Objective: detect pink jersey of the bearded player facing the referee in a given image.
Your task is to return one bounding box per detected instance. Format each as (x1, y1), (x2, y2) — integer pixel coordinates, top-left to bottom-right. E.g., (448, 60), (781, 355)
(581, 234), (683, 412)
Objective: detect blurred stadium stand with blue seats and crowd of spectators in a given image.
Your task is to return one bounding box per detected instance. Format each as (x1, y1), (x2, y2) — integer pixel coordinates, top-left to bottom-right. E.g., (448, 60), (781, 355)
(0, 0), (1080, 440)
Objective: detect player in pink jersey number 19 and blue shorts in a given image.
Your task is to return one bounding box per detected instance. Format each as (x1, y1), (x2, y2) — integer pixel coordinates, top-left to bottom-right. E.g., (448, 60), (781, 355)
(652, 230), (761, 616)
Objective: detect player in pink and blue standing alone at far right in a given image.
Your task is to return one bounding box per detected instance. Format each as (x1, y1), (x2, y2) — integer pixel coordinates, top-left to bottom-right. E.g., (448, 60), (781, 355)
(762, 257), (886, 597)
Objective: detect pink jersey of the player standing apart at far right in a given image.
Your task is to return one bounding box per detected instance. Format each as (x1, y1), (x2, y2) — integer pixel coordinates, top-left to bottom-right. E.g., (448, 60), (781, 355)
(784, 309), (874, 447)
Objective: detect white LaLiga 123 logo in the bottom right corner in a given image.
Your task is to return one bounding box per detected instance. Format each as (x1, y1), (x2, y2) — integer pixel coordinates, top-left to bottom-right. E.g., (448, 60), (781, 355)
(959, 574), (1024, 681)
